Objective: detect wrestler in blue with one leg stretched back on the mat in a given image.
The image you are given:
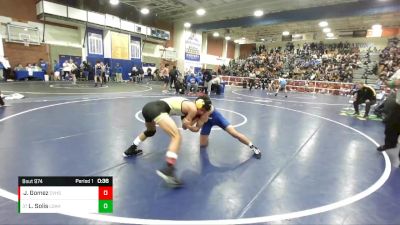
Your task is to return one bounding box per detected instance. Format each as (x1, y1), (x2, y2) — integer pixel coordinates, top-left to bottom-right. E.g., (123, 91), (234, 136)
(199, 106), (261, 159)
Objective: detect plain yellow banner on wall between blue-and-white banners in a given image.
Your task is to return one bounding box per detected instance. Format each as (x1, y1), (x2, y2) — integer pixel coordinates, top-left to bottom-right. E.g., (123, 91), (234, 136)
(111, 32), (129, 60)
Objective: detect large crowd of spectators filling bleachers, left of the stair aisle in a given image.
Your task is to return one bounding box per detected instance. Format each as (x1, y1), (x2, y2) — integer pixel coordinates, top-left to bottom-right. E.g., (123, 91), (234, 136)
(225, 42), (361, 82)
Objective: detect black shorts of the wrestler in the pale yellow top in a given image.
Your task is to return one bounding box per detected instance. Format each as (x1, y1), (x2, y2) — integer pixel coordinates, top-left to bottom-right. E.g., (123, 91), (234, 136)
(142, 100), (171, 123)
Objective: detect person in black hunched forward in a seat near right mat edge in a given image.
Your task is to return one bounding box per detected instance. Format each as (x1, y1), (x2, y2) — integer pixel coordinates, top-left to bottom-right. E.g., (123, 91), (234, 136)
(353, 82), (376, 118)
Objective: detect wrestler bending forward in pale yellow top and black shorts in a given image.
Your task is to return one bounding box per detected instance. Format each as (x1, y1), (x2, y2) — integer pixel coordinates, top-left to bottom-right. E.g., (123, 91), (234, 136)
(123, 96), (211, 187)
